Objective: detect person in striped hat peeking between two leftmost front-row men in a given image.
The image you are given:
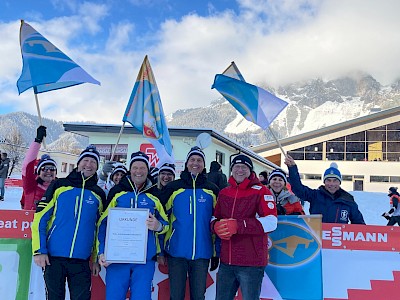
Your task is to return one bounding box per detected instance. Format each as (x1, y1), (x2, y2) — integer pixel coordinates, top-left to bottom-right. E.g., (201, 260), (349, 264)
(97, 161), (128, 196)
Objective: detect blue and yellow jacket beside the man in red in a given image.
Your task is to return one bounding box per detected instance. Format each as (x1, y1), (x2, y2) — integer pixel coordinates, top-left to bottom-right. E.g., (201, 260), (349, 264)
(161, 169), (219, 260)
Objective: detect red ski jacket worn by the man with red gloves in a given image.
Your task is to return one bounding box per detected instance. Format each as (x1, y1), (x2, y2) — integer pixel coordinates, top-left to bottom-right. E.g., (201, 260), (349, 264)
(211, 173), (277, 266)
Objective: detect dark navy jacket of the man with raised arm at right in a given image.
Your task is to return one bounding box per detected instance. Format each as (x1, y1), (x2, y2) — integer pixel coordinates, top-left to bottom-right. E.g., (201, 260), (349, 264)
(289, 165), (365, 224)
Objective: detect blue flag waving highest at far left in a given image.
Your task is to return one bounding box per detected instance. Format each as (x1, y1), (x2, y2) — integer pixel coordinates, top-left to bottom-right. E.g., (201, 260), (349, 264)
(17, 20), (100, 94)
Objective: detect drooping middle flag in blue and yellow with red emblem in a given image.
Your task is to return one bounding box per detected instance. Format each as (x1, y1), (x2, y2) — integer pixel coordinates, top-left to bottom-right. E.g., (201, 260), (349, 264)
(122, 55), (174, 162)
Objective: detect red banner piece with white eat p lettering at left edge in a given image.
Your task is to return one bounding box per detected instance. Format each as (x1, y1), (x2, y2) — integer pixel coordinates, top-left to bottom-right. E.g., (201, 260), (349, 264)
(0, 210), (35, 239)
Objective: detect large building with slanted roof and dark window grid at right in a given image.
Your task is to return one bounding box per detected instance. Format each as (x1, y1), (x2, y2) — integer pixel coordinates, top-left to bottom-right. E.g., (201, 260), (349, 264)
(251, 107), (400, 192)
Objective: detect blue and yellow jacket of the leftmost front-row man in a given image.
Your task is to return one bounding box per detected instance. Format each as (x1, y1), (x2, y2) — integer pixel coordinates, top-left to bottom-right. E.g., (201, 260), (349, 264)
(32, 169), (106, 259)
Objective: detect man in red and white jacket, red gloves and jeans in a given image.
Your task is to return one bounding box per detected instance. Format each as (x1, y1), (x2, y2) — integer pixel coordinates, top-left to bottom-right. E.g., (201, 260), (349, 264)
(211, 154), (277, 300)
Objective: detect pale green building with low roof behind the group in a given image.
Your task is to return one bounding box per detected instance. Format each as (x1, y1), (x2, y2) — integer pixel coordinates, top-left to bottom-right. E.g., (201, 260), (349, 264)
(64, 124), (277, 176)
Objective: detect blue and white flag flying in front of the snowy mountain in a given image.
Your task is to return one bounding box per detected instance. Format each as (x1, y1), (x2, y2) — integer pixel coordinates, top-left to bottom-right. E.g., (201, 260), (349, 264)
(211, 62), (288, 129)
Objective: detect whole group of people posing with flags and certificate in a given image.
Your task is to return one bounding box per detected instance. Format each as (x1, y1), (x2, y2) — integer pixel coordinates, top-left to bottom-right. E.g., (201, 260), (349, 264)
(25, 126), (365, 300)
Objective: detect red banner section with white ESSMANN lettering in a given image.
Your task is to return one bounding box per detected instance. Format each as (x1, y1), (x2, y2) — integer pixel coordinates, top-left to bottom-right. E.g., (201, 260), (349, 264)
(322, 223), (400, 252)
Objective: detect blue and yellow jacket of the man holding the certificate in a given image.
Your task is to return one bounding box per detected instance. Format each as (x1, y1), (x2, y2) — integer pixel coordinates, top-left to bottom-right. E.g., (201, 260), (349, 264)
(96, 175), (169, 260)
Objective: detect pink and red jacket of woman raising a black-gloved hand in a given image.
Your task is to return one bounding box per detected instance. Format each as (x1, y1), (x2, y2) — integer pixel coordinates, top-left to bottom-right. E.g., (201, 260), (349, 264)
(20, 142), (50, 210)
